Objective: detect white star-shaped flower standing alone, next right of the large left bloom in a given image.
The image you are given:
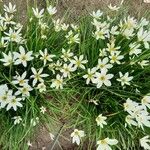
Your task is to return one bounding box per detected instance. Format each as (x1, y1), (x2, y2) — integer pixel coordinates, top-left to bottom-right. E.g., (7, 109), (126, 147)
(39, 48), (55, 66)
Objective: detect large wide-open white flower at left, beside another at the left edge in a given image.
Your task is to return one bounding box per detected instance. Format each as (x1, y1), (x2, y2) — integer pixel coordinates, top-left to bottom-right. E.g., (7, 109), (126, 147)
(13, 46), (34, 67)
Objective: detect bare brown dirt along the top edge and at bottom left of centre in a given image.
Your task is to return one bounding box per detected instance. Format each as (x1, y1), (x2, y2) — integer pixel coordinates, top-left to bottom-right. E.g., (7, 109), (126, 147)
(0, 0), (150, 150)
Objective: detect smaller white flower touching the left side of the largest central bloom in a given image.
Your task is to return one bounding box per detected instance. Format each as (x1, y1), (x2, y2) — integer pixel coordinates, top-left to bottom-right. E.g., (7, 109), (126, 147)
(83, 67), (97, 84)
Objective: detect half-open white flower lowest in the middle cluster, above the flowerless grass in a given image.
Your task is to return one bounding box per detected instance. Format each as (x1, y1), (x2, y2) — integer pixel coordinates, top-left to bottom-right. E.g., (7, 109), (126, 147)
(51, 74), (63, 89)
